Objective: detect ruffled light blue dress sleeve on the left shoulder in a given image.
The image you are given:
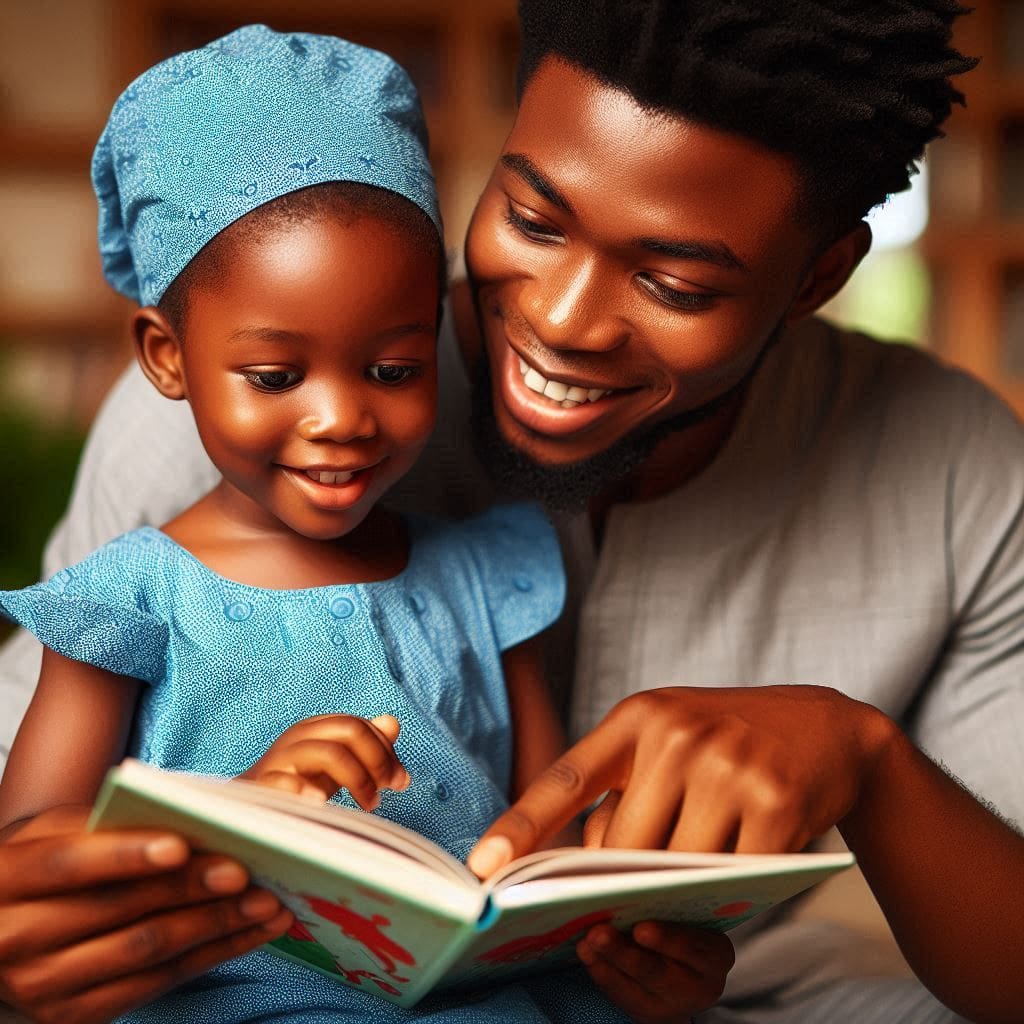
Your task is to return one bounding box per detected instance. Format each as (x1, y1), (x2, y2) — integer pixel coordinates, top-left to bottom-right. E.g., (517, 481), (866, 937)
(0, 541), (168, 683)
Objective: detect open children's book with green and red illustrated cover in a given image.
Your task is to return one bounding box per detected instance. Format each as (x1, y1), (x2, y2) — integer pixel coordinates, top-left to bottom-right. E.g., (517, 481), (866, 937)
(89, 760), (853, 1007)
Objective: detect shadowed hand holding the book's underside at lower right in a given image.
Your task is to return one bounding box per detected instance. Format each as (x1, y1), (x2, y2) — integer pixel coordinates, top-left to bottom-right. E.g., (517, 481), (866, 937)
(577, 921), (735, 1024)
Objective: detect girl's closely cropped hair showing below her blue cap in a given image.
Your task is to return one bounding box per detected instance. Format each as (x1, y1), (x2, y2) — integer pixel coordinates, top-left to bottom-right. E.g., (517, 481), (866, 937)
(158, 181), (447, 338)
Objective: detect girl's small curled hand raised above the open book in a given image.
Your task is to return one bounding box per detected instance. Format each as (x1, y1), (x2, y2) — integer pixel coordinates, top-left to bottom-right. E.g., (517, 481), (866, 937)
(239, 715), (410, 811)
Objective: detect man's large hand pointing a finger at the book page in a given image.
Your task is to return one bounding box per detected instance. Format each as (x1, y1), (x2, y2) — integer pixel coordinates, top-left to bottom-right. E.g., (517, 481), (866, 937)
(469, 686), (896, 878)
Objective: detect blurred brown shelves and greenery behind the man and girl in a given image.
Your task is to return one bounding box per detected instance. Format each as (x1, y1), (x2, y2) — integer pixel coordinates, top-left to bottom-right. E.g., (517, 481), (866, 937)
(0, 0), (1024, 602)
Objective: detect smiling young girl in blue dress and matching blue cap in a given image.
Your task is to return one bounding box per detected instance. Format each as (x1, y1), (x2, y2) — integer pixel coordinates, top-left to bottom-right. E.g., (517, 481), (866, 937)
(0, 27), (712, 1024)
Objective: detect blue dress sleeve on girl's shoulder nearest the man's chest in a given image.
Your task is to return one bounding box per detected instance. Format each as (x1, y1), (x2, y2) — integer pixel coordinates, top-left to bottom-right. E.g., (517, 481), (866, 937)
(460, 504), (565, 650)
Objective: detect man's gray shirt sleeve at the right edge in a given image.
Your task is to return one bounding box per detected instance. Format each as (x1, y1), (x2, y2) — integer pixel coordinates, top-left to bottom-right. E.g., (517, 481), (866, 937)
(909, 380), (1024, 824)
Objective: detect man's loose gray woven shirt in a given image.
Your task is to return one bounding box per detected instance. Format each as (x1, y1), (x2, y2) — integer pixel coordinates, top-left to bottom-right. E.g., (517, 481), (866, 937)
(0, 321), (1011, 1024)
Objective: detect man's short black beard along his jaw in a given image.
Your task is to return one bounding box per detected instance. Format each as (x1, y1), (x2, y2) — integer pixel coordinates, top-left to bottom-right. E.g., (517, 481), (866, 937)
(470, 324), (782, 513)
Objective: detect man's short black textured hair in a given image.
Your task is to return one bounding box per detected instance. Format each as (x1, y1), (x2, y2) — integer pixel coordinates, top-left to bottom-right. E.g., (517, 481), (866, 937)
(518, 0), (978, 238)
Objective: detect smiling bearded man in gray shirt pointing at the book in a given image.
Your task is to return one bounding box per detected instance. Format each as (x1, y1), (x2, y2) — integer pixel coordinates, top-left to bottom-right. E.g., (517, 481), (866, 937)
(0, 0), (1024, 1024)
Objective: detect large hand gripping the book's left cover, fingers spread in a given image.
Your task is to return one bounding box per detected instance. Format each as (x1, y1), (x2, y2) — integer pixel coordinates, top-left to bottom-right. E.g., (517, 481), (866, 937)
(0, 807), (293, 1024)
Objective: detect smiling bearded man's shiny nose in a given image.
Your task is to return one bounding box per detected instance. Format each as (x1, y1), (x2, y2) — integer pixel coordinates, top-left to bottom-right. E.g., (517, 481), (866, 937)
(523, 259), (629, 351)
